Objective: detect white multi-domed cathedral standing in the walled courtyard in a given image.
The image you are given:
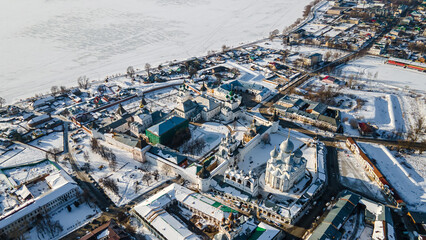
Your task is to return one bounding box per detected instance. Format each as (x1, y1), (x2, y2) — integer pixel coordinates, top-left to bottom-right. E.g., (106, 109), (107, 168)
(265, 136), (307, 192)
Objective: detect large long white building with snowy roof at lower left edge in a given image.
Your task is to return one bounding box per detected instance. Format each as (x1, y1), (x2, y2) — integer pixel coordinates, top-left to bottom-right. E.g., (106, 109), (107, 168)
(0, 160), (80, 235)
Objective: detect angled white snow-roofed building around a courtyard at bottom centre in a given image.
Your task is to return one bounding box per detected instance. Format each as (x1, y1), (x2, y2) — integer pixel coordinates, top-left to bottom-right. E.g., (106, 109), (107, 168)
(132, 183), (281, 240)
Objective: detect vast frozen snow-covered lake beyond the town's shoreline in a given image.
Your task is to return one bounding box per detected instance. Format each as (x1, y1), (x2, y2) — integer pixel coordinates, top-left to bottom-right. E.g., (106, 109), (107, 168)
(0, 0), (311, 103)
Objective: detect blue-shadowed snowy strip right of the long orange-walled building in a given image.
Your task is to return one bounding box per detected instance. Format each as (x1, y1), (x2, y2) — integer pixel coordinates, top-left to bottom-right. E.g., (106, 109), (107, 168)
(359, 143), (426, 212)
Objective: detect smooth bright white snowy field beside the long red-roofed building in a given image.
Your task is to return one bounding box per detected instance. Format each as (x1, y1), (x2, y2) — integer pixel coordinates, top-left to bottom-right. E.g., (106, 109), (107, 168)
(340, 56), (426, 93)
